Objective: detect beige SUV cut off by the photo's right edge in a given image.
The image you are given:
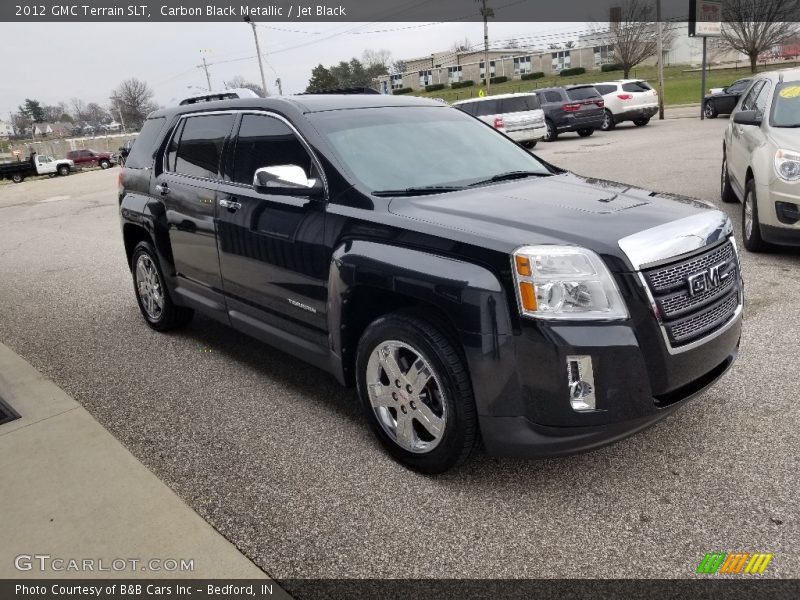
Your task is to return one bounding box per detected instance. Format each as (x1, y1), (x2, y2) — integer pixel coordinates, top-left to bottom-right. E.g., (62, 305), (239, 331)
(720, 69), (800, 252)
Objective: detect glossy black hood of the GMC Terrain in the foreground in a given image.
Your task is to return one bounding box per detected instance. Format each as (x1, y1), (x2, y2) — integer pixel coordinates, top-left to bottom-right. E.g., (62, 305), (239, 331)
(389, 173), (713, 270)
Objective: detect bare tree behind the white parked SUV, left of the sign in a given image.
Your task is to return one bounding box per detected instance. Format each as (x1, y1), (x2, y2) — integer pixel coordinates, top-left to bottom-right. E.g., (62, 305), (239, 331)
(598, 0), (675, 79)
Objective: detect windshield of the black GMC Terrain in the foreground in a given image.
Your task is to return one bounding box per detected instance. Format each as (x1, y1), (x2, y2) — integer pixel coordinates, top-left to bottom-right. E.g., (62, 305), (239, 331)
(309, 106), (551, 191)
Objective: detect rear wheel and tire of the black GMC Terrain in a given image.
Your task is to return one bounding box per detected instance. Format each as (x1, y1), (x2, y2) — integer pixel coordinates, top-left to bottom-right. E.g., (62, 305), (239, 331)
(131, 242), (194, 331)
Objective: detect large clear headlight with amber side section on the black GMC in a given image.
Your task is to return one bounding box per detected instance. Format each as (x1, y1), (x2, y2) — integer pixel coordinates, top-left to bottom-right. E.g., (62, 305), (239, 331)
(512, 246), (628, 321)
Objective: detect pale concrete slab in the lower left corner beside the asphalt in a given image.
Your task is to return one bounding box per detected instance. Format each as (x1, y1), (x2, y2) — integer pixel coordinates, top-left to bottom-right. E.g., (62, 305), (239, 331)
(0, 344), (278, 584)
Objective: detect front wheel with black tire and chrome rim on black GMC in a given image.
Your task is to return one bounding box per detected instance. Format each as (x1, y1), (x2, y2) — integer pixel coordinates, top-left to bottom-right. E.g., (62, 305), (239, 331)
(356, 312), (478, 474)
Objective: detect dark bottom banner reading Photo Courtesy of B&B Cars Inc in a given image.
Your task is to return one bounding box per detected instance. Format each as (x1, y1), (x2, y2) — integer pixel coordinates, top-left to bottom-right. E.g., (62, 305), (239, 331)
(0, 576), (800, 600)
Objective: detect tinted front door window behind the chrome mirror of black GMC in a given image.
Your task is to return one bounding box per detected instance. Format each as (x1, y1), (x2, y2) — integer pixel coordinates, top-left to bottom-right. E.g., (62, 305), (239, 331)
(231, 115), (311, 185)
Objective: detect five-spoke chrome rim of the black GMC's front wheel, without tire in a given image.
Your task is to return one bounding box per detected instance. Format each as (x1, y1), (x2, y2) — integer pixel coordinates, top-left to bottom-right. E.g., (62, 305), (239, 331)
(366, 340), (447, 453)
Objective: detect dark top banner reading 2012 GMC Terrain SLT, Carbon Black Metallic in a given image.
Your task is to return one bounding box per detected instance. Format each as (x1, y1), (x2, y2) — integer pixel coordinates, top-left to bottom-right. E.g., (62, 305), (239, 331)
(0, 0), (800, 23)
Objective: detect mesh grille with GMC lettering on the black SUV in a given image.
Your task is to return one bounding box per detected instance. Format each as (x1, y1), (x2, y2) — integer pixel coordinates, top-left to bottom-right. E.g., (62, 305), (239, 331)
(642, 240), (741, 348)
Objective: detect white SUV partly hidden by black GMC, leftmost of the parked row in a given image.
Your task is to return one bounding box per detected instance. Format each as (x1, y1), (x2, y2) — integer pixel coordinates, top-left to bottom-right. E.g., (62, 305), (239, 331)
(453, 93), (547, 148)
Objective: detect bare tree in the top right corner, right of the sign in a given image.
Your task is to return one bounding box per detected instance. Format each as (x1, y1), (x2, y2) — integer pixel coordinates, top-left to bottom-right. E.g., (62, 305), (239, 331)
(722, 0), (800, 73)
